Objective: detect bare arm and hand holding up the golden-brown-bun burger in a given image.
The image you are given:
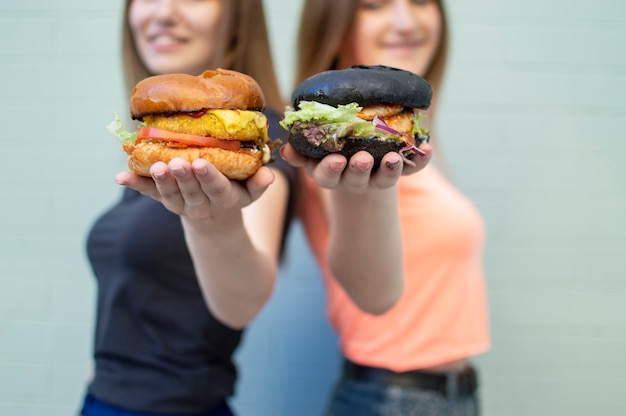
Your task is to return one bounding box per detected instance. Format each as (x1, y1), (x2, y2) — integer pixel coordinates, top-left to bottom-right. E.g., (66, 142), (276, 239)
(116, 159), (288, 328)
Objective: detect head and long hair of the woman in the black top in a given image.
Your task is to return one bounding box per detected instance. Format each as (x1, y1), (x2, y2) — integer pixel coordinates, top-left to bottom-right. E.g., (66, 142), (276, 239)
(122, 0), (284, 112)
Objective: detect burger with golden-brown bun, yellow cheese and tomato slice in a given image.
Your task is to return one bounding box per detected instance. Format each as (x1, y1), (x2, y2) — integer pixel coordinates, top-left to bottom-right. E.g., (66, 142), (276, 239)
(109, 69), (280, 180)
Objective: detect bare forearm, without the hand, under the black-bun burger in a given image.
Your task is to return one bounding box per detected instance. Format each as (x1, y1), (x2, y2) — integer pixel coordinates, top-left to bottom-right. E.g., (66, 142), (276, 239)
(328, 186), (403, 314)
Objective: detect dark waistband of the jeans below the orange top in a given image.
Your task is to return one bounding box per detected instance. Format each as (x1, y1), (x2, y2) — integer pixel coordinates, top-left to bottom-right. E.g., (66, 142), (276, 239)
(343, 360), (478, 397)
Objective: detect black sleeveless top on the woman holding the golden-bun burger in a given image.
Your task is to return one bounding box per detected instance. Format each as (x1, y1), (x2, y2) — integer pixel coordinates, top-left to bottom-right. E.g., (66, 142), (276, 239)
(87, 112), (296, 413)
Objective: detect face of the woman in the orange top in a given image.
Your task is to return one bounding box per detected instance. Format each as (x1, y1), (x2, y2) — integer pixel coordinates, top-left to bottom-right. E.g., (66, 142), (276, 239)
(339, 0), (442, 75)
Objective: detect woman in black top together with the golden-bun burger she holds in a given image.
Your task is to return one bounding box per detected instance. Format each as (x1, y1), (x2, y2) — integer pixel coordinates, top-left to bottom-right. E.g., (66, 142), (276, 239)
(82, 0), (295, 416)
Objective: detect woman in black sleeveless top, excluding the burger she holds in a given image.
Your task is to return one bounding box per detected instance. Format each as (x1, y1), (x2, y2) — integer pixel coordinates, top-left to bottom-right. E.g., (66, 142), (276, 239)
(82, 0), (295, 416)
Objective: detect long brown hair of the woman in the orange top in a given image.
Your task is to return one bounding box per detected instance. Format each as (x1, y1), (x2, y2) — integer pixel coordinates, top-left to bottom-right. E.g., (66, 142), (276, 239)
(295, 0), (449, 103)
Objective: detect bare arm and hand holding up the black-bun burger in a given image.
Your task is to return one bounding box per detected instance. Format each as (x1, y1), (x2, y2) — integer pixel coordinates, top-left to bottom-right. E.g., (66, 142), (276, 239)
(282, 144), (432, 314)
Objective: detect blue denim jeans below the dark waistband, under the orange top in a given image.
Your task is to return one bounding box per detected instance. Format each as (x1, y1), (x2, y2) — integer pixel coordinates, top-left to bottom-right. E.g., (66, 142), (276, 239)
(325, 380), (479, 416)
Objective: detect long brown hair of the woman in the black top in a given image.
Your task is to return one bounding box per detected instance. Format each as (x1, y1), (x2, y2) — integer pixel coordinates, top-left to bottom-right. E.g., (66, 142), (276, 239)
(122, 0), (284, 112)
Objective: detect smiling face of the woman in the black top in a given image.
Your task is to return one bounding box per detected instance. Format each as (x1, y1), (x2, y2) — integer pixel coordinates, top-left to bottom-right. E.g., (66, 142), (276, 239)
(128, 0), (222, 75)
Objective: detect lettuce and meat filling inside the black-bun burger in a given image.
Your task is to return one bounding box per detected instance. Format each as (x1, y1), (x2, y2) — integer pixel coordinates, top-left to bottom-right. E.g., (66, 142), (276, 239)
(280, 101), (429, 160)
